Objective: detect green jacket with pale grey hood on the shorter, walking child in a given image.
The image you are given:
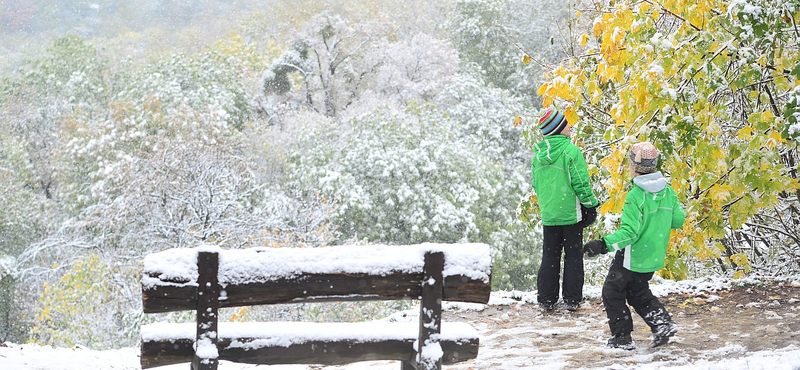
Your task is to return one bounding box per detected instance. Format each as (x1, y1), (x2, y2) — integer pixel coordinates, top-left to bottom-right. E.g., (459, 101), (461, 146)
(603, 172), (686, 273)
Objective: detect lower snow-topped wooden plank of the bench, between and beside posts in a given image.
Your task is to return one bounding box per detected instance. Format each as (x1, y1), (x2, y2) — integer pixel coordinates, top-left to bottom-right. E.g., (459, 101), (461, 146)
(142, 322), (479, 369)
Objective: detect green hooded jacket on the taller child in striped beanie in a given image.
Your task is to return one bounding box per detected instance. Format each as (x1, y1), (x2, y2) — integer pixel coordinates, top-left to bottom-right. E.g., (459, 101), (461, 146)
(531, 135), (599, 226)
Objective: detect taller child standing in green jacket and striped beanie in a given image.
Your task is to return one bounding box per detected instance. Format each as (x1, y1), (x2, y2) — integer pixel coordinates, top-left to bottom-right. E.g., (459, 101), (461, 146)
(531, 109), (599, 311)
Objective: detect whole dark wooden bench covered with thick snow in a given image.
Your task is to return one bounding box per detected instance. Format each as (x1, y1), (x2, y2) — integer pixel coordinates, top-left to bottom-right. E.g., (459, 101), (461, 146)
(141, 244), (491, 370)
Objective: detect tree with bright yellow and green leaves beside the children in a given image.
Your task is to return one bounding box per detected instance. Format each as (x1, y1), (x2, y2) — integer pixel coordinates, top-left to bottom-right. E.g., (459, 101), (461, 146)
(539, 0), (800, 277)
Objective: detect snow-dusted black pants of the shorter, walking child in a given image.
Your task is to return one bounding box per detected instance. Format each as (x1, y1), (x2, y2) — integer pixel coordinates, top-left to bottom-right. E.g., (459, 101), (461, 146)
(603, 250), (672, 335)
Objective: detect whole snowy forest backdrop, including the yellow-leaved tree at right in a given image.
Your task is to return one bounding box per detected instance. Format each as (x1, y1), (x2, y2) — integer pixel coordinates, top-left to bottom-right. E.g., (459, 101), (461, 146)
(0, 0), (800, 349)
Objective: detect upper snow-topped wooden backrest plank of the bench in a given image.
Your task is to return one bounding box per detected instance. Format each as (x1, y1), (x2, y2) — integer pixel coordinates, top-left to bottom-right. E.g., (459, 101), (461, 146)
(142, 244), (491, 313)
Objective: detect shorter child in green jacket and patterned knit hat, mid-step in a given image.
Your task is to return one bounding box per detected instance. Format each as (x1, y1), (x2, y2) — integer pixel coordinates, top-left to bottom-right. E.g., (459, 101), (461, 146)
(584, 142), (685, 350)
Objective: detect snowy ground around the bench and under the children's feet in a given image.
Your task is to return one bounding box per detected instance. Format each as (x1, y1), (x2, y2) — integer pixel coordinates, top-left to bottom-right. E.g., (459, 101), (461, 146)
(0, 279), (800, 370)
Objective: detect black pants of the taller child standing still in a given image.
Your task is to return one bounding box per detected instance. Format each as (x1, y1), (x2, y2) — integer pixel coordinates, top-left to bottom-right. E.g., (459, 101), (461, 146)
(536, 225), (583, 304)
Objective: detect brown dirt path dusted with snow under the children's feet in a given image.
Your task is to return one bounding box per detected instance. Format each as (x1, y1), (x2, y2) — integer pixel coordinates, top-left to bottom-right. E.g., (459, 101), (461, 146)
(443, 284), (800, 370)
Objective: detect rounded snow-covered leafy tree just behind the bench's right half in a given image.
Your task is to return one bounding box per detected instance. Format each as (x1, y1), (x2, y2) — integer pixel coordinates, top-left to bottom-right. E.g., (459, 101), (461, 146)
(293, 108), (499, 244)
